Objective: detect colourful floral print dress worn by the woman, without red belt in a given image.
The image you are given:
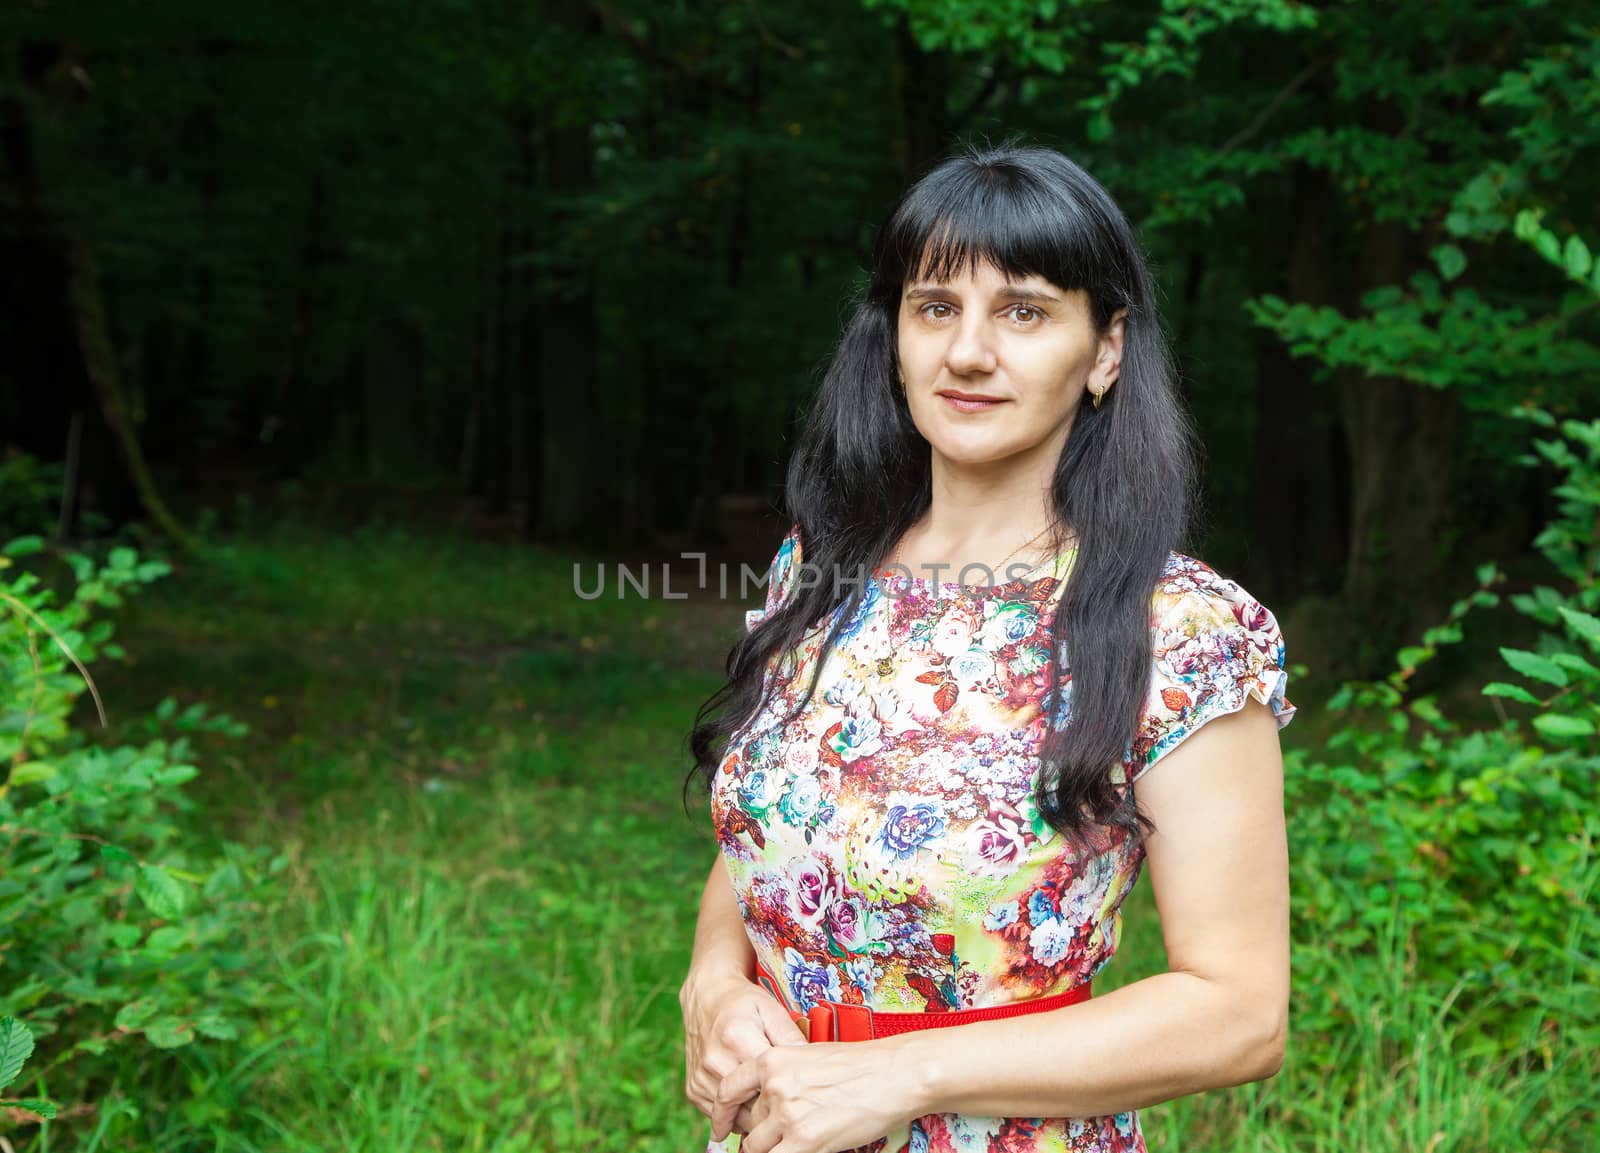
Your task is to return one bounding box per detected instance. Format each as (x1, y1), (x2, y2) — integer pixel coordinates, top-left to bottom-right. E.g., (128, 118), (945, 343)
(707, 525), (1294, 1153)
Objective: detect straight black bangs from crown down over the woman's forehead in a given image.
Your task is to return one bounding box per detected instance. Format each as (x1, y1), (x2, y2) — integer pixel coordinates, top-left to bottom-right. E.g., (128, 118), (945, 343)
(872, 154), (1110, 315)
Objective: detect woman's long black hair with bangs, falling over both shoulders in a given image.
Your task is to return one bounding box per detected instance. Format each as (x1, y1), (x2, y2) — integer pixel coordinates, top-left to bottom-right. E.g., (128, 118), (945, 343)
(685, 141), (1197, 846)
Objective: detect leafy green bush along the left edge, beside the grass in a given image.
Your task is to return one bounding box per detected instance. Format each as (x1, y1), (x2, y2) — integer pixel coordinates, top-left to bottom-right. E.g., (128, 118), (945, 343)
(0, 537), (275, 1145)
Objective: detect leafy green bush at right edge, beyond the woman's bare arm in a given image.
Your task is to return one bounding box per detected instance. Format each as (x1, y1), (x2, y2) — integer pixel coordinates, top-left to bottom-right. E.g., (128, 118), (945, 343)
(1286, 409), (1600, 1052)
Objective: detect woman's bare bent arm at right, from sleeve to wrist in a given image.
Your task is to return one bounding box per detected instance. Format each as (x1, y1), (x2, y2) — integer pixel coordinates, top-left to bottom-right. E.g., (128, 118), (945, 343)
(890, 699), (1290, 1116)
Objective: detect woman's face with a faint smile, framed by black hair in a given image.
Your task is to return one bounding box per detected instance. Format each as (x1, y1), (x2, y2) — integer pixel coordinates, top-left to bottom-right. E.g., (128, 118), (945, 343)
(899, 264), (1126, 464)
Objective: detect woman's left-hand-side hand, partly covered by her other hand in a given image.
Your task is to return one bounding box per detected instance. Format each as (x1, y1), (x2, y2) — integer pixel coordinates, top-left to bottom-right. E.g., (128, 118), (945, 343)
(678, 972), (806, 1140)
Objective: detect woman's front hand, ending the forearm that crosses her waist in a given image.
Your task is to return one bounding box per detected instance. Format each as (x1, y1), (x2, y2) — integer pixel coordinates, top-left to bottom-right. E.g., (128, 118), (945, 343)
(710, 1036), (928, 1153)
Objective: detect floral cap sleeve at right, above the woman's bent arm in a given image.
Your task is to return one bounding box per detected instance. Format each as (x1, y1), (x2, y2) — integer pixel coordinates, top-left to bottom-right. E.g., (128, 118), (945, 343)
(1120, 558), (1294, 784)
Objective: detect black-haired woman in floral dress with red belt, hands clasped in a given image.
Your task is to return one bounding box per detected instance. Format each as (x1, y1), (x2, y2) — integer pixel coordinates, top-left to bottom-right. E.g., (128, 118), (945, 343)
(680, 144), (1294, 1153)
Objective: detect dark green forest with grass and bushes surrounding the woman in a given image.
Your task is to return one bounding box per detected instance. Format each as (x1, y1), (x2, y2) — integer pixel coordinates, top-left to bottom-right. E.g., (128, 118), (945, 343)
(0, 0), (1600, 1153)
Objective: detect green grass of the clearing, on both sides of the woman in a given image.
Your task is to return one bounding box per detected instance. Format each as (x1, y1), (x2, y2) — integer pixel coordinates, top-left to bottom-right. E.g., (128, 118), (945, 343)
(21, 533), (1597, 1153)
